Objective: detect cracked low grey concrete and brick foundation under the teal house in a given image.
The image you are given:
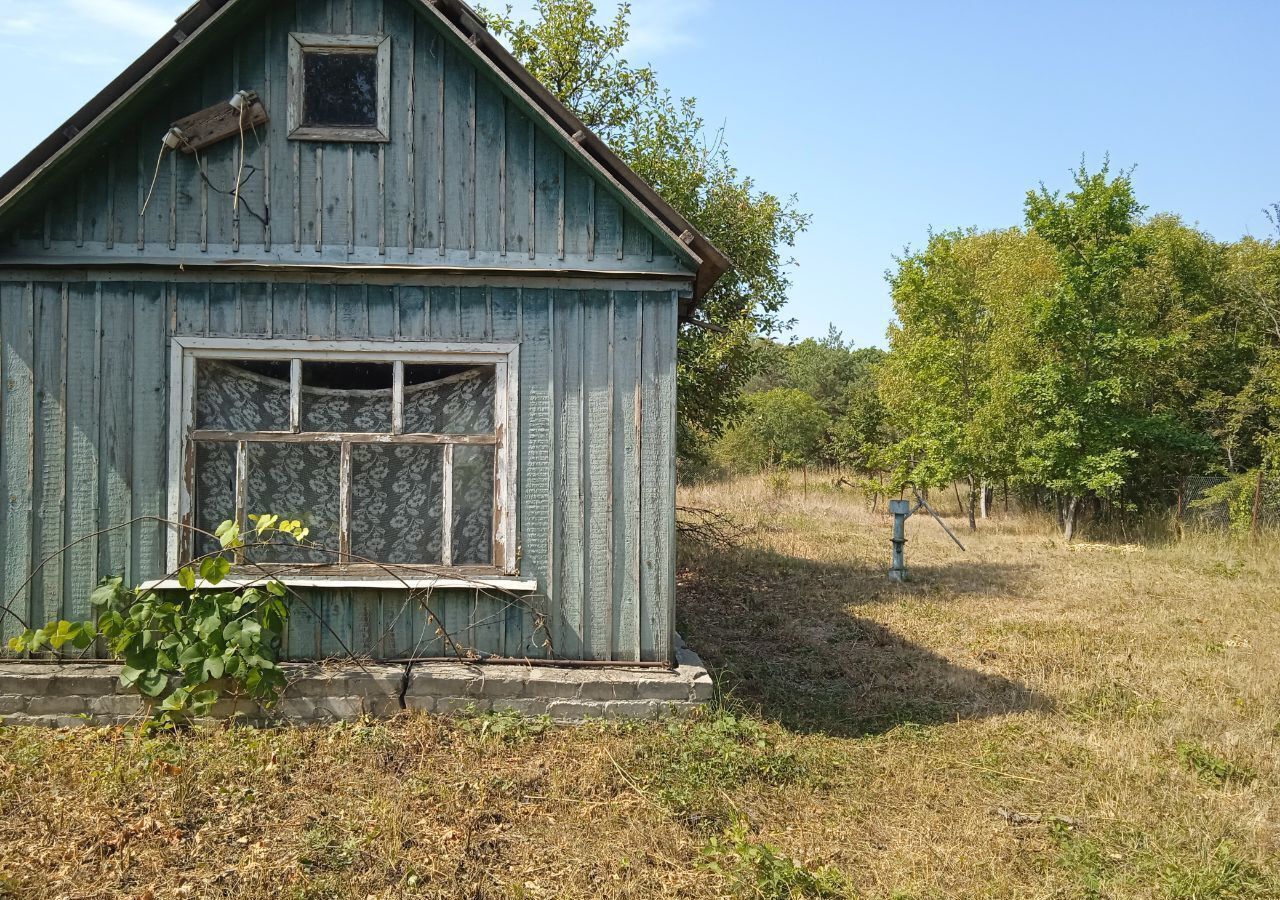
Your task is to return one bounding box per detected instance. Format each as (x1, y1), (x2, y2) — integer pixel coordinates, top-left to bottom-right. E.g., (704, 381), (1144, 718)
(0, 647), (712, 727)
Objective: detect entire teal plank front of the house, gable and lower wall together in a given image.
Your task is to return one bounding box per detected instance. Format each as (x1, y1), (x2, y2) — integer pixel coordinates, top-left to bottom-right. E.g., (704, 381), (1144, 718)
(0, 0), (694, 661)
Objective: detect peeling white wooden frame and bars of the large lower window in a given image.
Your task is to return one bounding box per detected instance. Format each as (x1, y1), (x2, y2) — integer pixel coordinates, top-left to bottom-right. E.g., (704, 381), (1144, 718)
(166, 337), (520, 581)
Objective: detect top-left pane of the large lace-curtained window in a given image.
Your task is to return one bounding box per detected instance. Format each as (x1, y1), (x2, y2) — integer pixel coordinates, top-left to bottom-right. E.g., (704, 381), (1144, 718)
(196, 360), (289, 431)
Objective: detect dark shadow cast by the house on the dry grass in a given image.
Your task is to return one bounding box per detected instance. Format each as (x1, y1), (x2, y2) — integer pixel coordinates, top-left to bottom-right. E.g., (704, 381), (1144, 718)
(678, 550), (1051, 736)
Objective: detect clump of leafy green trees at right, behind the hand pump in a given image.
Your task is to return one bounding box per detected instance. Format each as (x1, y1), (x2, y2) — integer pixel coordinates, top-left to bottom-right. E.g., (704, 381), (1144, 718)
(878, 168), (1280, 535)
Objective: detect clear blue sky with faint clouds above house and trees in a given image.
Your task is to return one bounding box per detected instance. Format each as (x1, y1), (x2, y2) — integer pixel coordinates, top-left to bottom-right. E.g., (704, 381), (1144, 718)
(0, 0), (1280, 346)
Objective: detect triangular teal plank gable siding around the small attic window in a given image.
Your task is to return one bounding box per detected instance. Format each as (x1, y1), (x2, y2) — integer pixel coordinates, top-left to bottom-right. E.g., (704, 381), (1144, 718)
(3, 0), (691, 281)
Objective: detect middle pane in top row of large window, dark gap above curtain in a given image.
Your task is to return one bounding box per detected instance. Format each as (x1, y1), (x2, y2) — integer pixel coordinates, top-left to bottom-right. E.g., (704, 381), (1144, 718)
(302, 361), (392, 434)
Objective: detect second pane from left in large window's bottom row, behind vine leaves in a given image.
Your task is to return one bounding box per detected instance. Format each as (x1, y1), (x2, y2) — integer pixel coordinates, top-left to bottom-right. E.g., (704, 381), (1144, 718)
(244, 443), (342, 563)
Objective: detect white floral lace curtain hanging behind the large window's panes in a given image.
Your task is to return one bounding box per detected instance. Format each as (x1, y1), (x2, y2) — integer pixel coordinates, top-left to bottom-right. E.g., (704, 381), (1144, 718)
(195, 360), (497, 566)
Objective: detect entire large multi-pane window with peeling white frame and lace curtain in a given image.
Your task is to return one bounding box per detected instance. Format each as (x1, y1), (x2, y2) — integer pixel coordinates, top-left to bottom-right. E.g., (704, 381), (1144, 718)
(175, 338), (516, 576)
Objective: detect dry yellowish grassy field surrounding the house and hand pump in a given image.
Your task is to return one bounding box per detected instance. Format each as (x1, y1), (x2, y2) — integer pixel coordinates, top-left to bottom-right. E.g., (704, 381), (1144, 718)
(0, 479), (1280, 900)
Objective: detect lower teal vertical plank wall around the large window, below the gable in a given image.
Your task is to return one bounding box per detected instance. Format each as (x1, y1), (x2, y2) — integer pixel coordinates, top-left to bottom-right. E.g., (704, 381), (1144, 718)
(0, 277), (677, 661)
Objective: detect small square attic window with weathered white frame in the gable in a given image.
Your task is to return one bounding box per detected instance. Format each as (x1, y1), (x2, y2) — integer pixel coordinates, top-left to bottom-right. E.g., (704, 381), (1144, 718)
(289, 35), (392, 141)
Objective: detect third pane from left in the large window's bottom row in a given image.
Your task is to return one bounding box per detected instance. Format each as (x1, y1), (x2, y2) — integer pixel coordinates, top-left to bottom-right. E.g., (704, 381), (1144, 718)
(351, 444), (444, 565)
